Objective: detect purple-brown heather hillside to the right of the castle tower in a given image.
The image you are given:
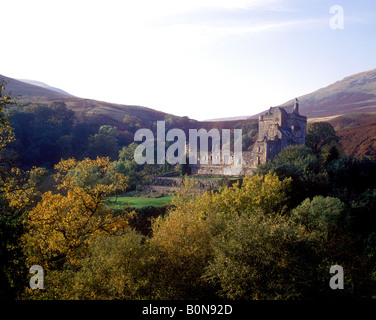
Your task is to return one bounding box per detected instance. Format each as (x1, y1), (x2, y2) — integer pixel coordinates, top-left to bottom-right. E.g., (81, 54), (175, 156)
(251, 69), (376, 160)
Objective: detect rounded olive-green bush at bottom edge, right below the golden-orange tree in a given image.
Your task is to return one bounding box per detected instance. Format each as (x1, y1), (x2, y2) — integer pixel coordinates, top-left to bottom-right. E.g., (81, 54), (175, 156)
(70, 231), (153, 300)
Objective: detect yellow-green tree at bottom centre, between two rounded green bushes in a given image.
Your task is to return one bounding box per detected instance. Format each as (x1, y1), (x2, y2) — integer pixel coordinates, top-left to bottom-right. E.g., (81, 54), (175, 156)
(149, 199), (214, 299)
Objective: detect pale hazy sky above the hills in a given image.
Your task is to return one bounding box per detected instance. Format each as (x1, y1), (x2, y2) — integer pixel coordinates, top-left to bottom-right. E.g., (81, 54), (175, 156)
(0, 0), (376, 120)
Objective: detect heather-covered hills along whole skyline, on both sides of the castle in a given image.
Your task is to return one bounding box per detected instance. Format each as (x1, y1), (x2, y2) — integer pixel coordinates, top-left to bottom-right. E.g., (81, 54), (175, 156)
(0, 69), (376, 159)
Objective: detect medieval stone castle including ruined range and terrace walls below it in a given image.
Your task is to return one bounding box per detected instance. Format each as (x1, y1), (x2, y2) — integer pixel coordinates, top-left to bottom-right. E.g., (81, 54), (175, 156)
(137, 99), (307, 194)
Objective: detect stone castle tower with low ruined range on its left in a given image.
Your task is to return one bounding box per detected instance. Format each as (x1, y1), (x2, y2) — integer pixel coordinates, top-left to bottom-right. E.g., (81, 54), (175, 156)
(189, 99), (307, 175)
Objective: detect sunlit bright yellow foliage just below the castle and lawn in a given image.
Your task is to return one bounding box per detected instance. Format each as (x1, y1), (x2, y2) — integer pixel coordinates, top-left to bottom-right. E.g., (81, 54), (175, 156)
(153, 174), (291, 255)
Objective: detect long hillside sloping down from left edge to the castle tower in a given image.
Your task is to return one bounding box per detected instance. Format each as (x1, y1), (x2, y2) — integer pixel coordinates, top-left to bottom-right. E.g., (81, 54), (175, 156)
(0, 75), (255, 130)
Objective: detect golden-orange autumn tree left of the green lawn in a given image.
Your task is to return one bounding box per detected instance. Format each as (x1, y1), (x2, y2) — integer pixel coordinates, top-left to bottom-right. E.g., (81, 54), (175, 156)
(23, 158), (128, 269)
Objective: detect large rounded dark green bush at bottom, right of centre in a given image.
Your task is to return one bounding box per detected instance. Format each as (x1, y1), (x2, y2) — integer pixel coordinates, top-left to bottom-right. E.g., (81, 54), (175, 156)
(205, 212), (322, 300)
